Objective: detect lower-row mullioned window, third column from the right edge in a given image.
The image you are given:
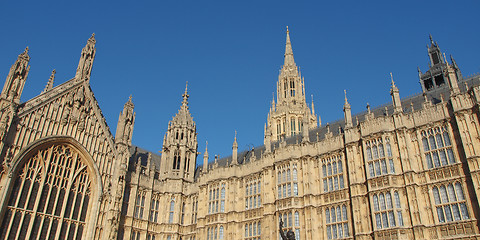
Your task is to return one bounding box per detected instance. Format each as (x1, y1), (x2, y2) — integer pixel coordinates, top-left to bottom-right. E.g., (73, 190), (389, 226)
(325, 205), (349, 239)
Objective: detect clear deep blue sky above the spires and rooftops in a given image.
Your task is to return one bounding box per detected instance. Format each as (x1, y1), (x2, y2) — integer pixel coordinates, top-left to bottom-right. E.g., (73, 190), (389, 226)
(0, 0), (480, 165)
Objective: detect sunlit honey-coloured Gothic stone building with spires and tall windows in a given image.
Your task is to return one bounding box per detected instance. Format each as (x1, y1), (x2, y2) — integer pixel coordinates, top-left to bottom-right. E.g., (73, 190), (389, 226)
(0, 30), (480, 240)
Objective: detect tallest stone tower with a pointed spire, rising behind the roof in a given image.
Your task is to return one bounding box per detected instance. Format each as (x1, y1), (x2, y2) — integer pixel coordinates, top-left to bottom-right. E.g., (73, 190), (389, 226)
(265, 27), (318, 141)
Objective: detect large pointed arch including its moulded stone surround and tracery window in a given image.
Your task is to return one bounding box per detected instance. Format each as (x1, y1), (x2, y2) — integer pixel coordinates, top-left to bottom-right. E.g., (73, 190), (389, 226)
(0, 136), (102, 239)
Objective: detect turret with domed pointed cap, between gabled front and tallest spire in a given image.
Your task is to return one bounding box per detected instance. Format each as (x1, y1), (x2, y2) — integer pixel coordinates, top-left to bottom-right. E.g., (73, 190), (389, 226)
(160, 84), (198, 182)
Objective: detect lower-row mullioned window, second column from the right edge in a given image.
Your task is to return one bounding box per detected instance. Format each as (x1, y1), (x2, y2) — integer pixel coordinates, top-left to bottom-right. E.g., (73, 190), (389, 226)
(373, 191), (403, 229)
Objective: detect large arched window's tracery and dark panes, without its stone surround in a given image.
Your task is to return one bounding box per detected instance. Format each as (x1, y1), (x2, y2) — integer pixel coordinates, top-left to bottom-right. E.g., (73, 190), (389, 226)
(0, 144), (92, 239)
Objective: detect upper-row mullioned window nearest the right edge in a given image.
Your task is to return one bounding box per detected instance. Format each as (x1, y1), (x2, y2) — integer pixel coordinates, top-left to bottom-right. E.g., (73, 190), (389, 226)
(422, 127), (455, 168)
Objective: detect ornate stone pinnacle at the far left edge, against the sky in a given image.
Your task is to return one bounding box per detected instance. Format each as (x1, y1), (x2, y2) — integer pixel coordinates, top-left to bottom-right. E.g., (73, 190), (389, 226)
(0, 47), (30, 104)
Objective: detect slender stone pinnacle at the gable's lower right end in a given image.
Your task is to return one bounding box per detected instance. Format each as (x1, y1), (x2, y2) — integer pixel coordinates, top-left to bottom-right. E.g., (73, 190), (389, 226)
(115, 95), (135, 146)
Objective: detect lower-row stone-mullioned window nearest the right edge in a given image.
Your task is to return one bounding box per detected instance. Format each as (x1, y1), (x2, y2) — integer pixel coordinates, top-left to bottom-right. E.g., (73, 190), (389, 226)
(432, 182), (470, 222)
